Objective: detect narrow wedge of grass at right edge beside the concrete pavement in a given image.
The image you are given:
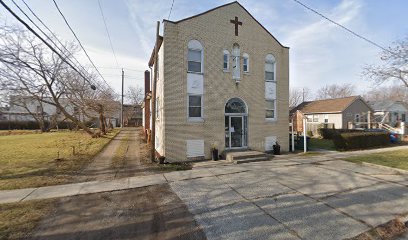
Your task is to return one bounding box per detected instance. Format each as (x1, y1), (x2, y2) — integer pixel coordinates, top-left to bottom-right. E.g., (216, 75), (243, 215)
(343, 150), (408, 170)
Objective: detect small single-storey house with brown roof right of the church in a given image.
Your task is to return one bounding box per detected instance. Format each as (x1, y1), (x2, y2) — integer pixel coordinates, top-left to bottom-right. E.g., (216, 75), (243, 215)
(291, 96), (373, 132)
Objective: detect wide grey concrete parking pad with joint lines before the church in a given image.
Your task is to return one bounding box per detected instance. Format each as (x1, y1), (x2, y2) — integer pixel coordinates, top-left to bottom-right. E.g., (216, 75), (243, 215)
(170, 156), (408, 239)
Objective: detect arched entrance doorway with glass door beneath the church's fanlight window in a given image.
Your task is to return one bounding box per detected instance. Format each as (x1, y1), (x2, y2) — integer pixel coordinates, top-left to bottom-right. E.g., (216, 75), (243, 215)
(225, 98), (248, 149)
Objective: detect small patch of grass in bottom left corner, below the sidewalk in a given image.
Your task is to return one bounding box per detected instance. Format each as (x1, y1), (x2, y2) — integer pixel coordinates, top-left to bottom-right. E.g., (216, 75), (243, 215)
(0, 199), (56, 240)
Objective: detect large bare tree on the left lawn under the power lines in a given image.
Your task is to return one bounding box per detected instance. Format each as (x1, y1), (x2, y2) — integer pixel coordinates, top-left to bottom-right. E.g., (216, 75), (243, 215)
(0, 22), (107, 135)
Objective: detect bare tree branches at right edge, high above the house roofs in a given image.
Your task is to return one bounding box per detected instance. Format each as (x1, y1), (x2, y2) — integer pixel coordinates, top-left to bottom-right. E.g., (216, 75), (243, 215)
(363, 36), (408, 88)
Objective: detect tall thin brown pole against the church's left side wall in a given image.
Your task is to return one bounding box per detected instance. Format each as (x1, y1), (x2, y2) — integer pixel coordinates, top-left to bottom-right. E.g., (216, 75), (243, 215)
(150, 21), (160, 162)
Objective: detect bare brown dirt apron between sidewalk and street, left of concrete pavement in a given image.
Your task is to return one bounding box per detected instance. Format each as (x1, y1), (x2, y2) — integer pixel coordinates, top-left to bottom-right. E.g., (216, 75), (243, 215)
(31, 184), (206, 240)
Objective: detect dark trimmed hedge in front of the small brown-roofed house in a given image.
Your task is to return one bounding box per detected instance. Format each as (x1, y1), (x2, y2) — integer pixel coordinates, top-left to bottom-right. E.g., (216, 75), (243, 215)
(333, 132), (390, 150)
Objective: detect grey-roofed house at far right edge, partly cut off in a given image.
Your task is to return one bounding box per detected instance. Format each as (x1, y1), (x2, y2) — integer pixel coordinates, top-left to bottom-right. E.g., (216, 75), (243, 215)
(368, 101), (408, 127)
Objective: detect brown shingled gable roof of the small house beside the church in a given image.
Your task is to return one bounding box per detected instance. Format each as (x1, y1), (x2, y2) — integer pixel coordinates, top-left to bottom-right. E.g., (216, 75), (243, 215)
(291, 96), (370, 114)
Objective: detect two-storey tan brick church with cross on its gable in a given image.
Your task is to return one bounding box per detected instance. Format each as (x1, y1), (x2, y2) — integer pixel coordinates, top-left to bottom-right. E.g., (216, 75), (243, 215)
(144, 2), (289, 162)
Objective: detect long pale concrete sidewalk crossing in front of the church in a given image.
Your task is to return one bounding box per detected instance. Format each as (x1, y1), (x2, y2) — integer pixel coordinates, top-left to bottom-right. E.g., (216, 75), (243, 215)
(0, 146), (408, 204)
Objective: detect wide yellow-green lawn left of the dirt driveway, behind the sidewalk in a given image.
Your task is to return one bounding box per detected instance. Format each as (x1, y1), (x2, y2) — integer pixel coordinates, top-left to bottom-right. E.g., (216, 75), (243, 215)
(0, 130), (119, 190)
